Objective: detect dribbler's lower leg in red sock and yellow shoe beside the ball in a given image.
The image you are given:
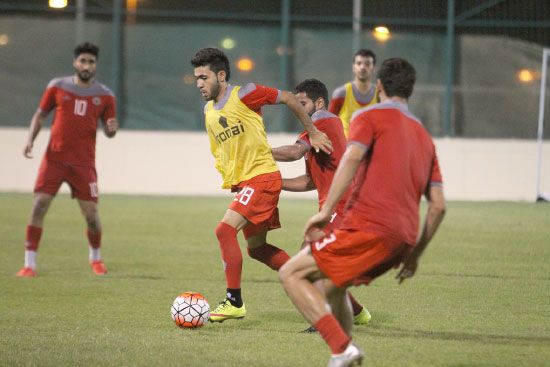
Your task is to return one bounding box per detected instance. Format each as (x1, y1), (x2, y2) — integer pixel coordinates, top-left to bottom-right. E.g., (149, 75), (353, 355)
(210, 222), (246, 322)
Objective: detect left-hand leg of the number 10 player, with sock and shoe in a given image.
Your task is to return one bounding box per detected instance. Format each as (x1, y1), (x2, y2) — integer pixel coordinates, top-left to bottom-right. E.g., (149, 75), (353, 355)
(15, 192), (53, 278)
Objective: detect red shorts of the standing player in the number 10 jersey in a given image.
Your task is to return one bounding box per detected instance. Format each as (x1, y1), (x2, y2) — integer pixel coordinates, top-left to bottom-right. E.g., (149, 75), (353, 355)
(34, 158), (98, 203)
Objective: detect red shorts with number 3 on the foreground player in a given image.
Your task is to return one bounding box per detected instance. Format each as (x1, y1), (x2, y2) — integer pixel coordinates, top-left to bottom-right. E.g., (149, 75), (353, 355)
(311, 229), (410, 287)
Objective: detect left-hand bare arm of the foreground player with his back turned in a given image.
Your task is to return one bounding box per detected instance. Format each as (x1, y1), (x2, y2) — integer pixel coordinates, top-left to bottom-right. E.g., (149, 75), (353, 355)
(304, 144), (366, 242)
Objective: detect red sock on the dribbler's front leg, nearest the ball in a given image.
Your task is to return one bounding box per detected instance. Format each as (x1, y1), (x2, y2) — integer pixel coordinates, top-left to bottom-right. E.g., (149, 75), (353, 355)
(216, 222), (243, 288)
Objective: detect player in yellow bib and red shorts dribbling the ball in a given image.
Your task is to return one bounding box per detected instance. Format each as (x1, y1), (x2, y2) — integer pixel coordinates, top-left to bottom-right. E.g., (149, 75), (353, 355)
(191, 48), (332, 322)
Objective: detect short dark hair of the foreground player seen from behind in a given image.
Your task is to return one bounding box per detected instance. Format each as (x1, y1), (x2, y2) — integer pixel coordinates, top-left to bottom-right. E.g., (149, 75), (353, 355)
(378, 57), (416, 98)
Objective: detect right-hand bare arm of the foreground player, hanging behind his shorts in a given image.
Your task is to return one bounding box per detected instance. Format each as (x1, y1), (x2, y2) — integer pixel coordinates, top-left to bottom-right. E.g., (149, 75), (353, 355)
(396, 186), (446, 284)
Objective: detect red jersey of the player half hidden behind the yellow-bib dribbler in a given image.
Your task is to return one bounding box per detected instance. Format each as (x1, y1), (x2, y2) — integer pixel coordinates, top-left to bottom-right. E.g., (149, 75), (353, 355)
(298, 110), (349, 214)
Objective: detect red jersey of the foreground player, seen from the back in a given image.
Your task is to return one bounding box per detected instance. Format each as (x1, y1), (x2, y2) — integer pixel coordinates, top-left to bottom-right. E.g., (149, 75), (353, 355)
(340, 101), (442, 245)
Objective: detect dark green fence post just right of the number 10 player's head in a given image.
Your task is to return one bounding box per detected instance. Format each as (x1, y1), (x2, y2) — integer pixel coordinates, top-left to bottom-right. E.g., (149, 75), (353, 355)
(111, 0), (124, 124)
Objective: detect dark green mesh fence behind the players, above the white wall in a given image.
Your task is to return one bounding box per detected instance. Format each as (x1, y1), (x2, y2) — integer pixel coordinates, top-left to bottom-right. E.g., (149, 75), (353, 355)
(0, 0), (550, 139)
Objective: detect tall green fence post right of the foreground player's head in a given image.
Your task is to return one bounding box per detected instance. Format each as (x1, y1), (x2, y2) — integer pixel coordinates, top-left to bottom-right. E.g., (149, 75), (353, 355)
(443, 0), (455, 136)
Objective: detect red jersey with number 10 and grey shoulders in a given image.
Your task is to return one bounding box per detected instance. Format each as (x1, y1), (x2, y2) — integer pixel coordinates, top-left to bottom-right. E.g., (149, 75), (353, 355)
(39, 76), (115, 167)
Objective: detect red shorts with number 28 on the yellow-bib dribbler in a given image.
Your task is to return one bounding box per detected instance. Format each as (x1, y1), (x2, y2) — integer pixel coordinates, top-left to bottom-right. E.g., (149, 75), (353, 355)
(229, 171), (283, 242)
